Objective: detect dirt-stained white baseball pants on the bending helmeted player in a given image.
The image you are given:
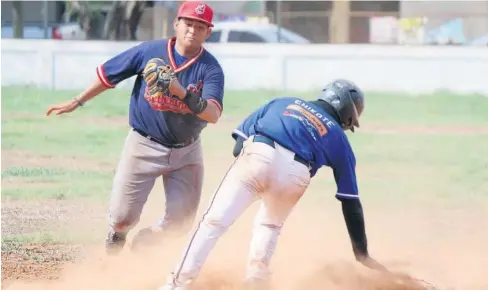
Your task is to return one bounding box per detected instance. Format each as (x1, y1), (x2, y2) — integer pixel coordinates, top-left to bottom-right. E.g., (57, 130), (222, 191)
(161, 136), (310, 289)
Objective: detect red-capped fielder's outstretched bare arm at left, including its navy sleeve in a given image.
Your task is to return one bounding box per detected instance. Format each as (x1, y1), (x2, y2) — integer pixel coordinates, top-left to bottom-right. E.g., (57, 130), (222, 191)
(46, 43), (145, 116)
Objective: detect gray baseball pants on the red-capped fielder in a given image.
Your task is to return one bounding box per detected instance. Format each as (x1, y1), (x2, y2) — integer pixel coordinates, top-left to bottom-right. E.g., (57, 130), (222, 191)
(109, 129), (203, 238)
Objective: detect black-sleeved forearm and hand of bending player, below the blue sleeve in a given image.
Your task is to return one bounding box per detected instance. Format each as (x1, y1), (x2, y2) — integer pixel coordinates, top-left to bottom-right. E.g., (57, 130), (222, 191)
(341, 199), (388, 272)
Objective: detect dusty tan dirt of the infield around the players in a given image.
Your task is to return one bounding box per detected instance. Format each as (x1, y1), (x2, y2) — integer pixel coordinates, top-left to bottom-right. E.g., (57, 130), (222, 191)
(2, 126), (488, 290)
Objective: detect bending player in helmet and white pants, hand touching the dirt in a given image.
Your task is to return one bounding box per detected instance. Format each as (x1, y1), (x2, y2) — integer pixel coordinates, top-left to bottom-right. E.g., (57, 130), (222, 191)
(160, 80), (386, 290)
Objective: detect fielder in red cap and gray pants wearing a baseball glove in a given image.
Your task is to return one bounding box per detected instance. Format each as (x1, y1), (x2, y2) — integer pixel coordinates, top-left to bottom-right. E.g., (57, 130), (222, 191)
(47, 1), (224, 254)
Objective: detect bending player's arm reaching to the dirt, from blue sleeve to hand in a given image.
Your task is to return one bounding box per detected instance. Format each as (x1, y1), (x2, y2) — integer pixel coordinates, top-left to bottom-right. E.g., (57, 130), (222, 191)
(331, 137), (387, 271)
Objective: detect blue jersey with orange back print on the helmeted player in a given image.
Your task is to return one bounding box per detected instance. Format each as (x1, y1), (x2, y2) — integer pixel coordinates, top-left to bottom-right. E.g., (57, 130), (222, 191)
(232, 97), (358, 199)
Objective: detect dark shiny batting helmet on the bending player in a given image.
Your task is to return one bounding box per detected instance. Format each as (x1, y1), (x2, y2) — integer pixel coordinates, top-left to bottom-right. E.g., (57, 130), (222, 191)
(318, 79), (364, 132)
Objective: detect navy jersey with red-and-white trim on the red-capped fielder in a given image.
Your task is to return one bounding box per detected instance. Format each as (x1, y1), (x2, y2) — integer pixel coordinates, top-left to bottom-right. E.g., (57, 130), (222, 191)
(97, 38), (224, 145)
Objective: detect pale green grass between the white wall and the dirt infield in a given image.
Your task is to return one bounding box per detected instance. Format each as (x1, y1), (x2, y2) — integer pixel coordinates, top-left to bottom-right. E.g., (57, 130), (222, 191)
(2, 87), (488, 198)
